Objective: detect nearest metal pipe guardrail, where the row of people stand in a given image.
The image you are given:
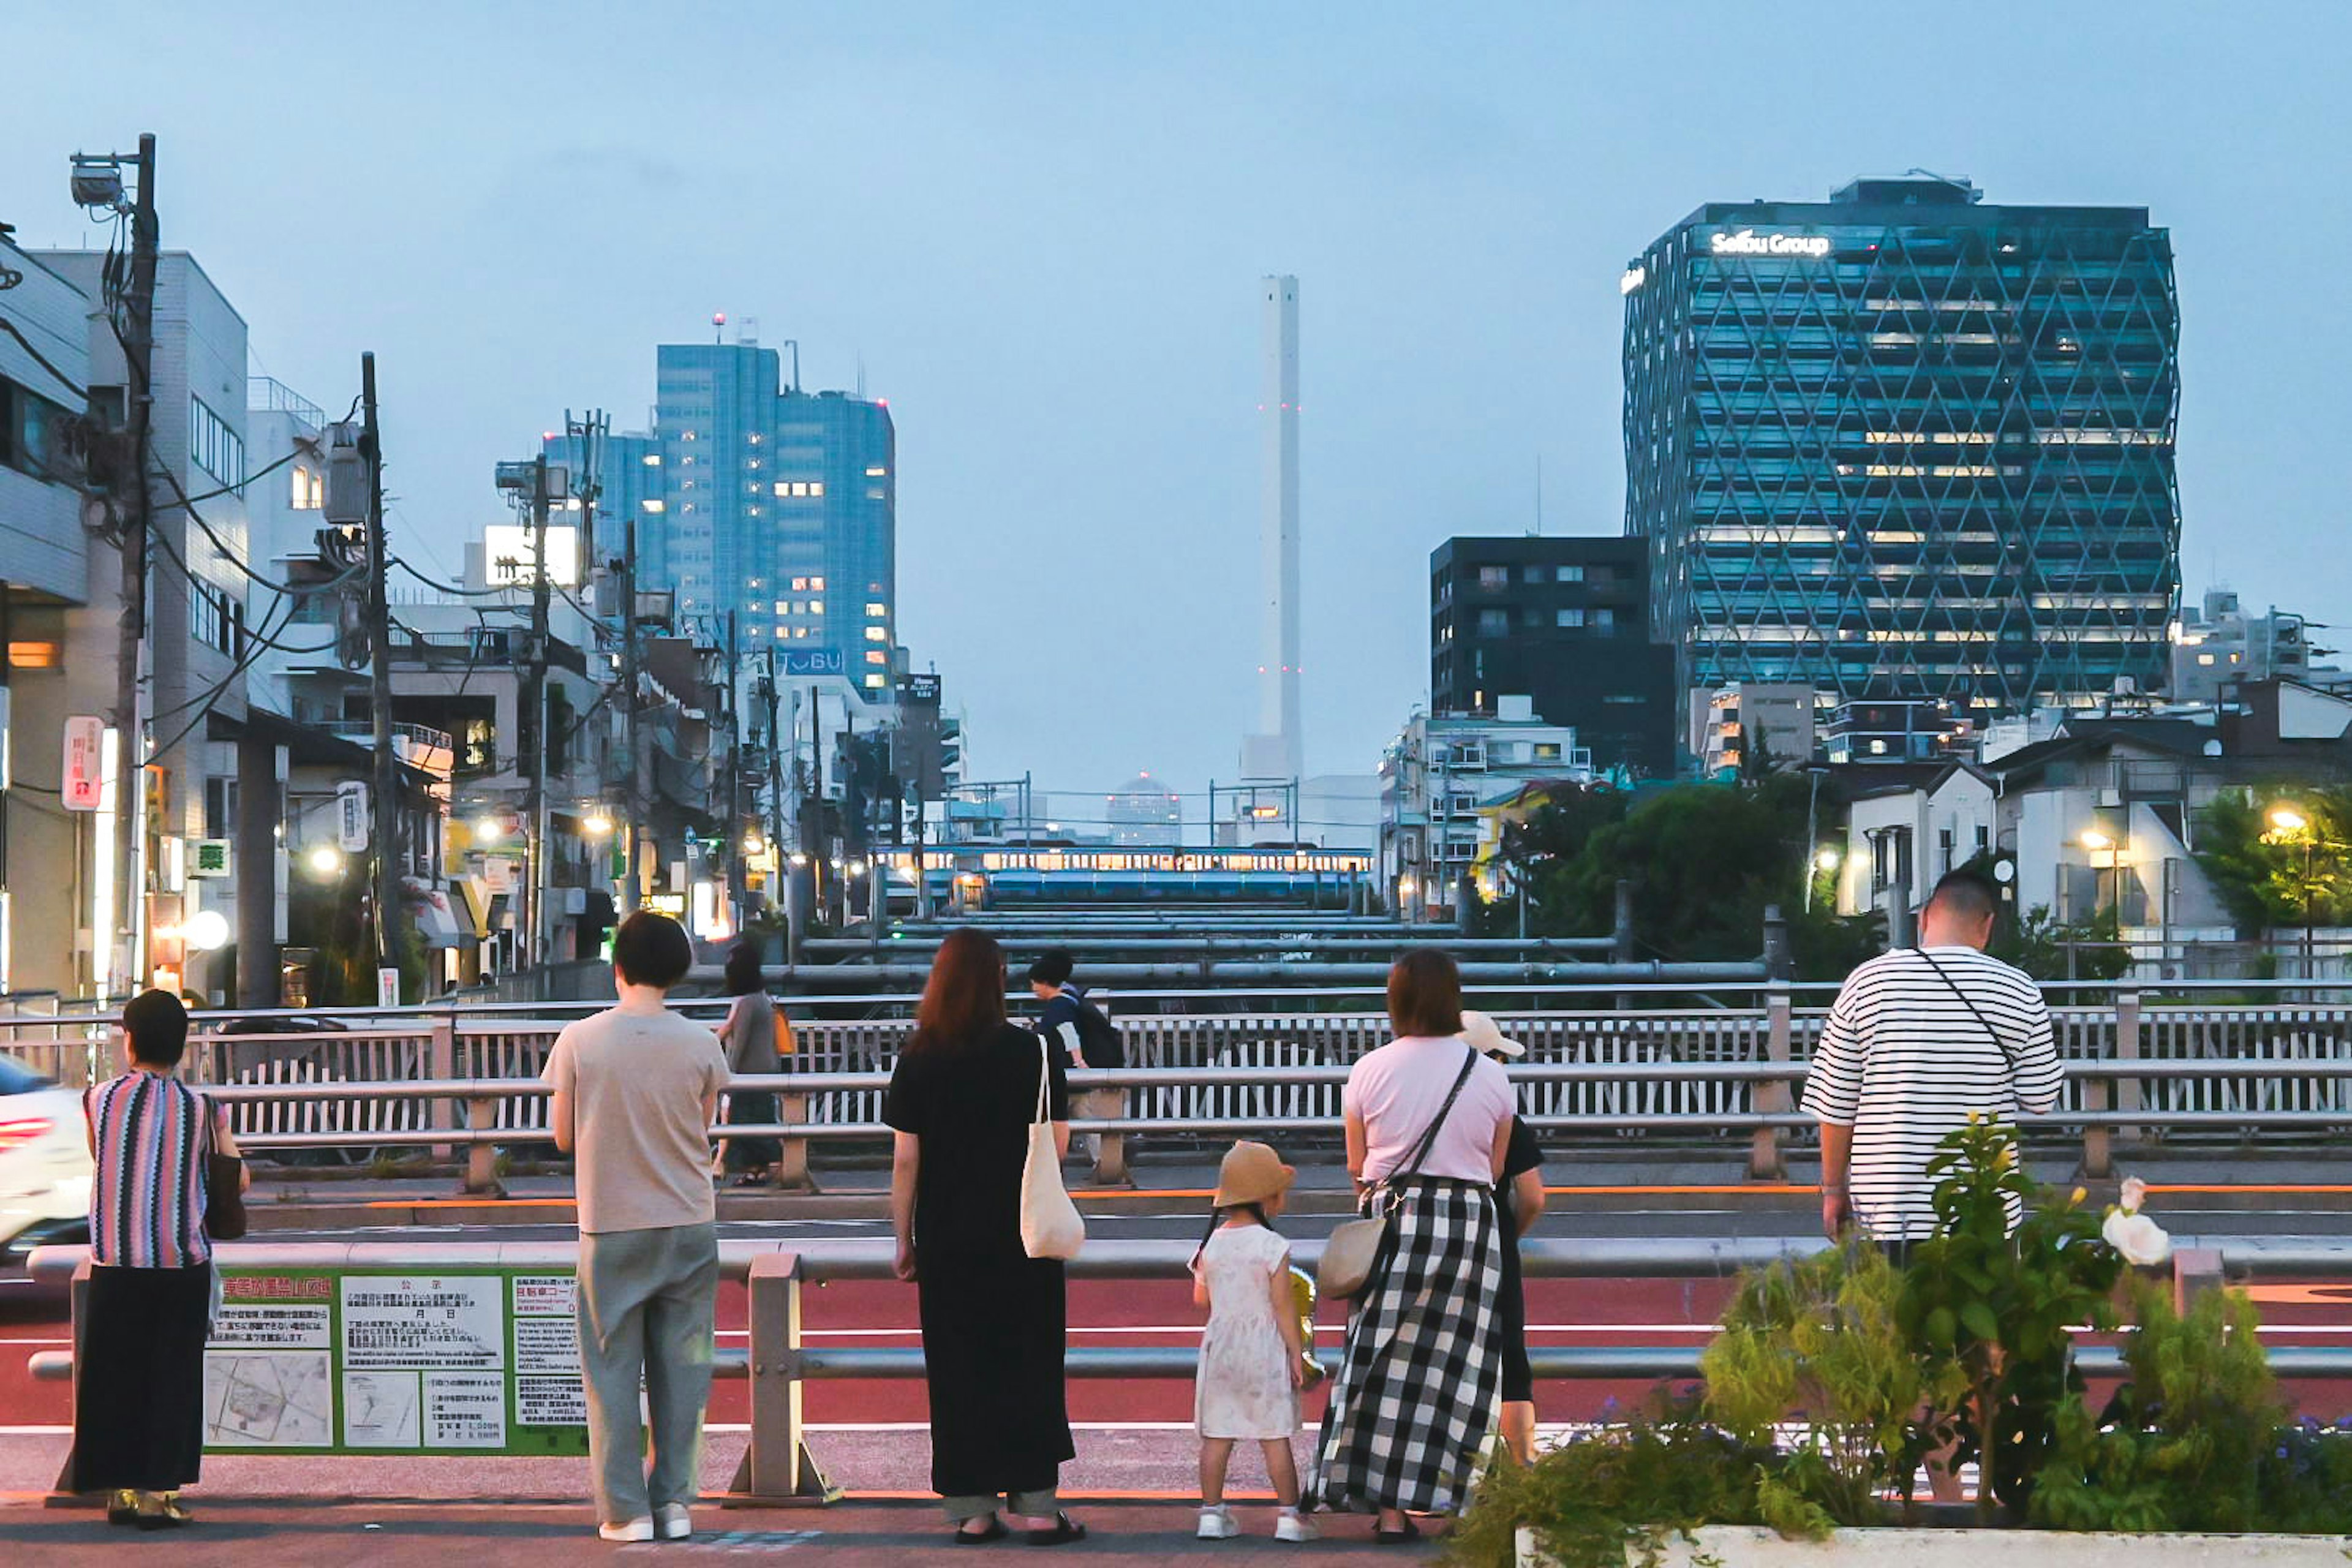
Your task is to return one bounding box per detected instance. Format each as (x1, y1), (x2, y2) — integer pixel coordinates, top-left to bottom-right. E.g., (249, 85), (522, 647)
(28, 1237), (2352, 1504)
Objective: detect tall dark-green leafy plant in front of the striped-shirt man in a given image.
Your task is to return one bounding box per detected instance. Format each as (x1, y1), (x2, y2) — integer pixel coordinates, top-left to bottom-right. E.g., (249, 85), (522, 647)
(1901, 1117), (2124, 1521)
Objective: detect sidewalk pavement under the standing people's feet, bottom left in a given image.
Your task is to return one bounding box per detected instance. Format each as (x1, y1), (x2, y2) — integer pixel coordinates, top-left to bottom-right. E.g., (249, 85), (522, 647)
(0, 1493), (1442, 1568)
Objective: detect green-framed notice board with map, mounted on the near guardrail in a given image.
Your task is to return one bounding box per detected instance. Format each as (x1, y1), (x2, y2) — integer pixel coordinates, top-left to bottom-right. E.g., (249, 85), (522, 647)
(205, 1265), (588, 1455)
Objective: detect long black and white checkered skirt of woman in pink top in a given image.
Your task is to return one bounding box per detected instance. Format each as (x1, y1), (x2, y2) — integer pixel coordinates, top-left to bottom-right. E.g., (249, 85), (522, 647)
(1310, 1178), (1503, 1514)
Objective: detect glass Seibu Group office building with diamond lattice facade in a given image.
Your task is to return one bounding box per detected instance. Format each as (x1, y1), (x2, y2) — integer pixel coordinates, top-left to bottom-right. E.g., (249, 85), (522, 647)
(1623, 179), (2180, 712)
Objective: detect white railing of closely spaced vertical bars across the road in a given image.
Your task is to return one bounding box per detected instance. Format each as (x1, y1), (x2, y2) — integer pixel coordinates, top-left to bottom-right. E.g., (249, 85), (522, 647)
(18, 995), (2352, 1136)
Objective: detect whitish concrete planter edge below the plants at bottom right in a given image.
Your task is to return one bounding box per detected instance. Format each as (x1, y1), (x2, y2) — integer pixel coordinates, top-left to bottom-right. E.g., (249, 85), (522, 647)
(1520, 1526), (2352, 1568)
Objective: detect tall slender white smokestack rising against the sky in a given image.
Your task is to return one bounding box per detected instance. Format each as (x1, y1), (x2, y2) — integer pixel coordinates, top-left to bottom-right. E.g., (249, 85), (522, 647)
(1242, 277), (1305, 780)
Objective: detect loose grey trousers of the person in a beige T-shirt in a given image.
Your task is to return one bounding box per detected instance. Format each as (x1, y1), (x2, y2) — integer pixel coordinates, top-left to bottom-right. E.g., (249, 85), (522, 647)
(579, 1225), (720, 1523)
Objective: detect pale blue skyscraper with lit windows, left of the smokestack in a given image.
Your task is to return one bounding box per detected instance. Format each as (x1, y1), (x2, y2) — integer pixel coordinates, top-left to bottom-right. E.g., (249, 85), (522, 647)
(548, 343), (899, 703)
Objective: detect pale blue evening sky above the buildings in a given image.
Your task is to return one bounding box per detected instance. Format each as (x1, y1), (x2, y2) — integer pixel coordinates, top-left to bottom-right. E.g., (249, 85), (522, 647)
(0, 0), (2352, 790)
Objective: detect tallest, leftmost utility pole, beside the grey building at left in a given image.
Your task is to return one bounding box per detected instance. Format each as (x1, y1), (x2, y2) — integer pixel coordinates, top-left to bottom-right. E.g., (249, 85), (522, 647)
(92, 134), (160, 997)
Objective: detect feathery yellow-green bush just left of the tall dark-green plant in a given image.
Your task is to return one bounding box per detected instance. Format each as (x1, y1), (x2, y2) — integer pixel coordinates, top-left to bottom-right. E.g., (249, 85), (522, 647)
(1700, 1242), (1957, 1532)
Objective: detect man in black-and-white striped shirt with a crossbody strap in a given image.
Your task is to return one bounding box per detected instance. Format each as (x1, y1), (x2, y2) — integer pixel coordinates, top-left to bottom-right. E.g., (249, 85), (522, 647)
(1804, 872), (2063, 1243)
